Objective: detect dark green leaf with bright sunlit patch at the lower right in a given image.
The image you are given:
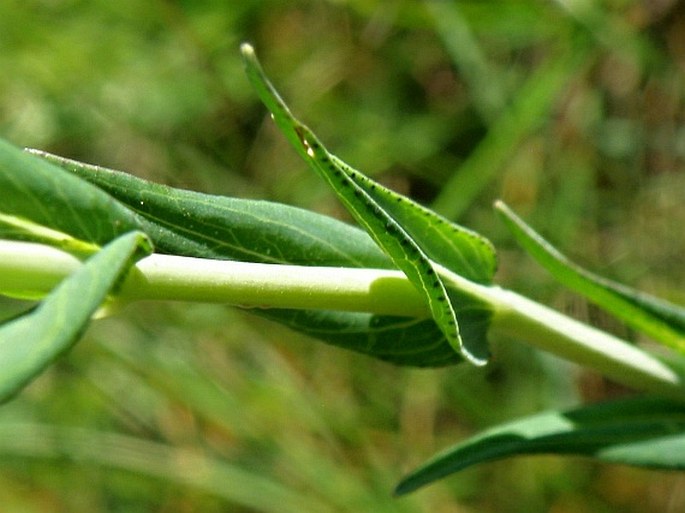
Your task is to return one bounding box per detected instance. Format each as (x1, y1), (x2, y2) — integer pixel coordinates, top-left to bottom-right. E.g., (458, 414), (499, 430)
(395, 397), (685, 495)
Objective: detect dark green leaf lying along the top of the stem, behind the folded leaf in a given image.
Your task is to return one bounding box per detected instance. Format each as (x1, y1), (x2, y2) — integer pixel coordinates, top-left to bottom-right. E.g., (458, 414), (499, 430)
(30, 150), (392, 269)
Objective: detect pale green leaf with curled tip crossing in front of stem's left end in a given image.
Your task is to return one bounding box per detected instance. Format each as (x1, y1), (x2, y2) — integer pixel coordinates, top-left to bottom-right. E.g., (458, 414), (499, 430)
(0, 232), (152, 402)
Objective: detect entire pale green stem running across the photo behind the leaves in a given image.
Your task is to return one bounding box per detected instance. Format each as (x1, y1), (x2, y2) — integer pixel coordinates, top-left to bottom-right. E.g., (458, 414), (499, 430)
(0, 240), (685, 398)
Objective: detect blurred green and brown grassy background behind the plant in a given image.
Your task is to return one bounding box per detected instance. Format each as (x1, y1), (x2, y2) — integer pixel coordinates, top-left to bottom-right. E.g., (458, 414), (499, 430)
(0, 0), (685, 513)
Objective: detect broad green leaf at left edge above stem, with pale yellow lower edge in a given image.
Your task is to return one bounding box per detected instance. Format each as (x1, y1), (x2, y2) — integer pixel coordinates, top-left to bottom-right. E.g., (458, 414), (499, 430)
(0, 139), (141, 253)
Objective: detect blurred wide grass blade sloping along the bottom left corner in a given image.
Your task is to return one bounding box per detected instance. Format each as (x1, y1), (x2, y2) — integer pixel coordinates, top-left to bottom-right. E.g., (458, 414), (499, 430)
(0, 423), (330, 513)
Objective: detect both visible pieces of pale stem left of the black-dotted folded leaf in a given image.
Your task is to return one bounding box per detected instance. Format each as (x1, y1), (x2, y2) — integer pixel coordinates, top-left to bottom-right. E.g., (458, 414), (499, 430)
(0, 240), (430, 317)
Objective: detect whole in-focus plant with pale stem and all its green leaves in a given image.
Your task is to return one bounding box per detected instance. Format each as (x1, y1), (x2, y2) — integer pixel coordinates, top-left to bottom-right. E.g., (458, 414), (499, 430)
(0, 44), (685, 494)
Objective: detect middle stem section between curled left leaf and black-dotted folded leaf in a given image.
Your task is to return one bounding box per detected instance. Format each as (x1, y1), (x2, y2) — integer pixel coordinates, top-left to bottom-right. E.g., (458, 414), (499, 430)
(120, 255), (422, 317)
